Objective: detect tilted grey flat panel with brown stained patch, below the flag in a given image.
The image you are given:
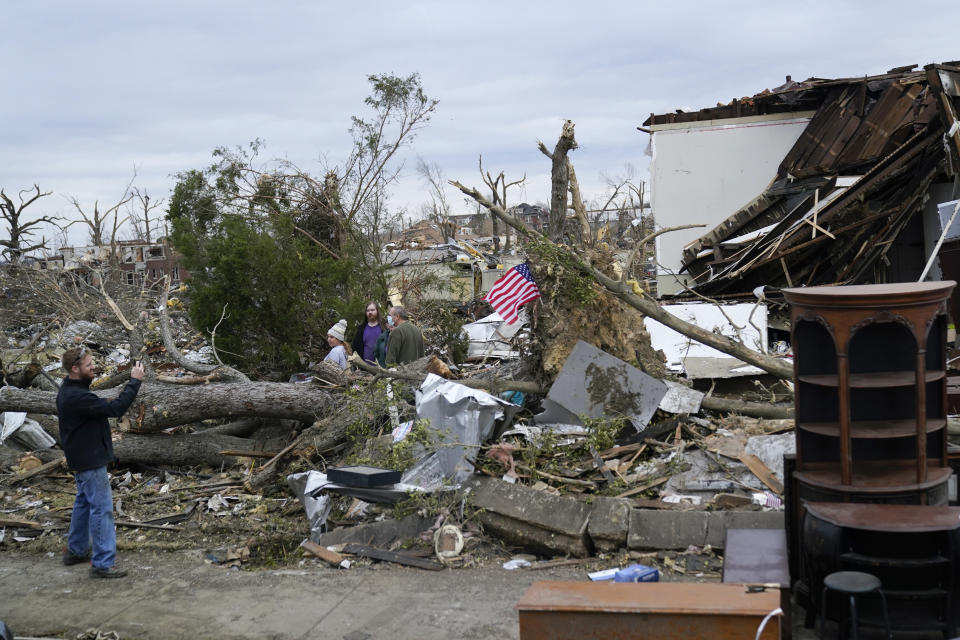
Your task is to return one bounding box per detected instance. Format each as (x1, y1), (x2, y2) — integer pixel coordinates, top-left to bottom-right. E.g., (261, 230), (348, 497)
(547, 340), (667, 431)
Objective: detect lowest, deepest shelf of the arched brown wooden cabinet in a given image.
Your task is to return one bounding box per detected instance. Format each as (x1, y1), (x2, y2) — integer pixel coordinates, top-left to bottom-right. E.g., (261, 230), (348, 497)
(794, 460), (953, 494)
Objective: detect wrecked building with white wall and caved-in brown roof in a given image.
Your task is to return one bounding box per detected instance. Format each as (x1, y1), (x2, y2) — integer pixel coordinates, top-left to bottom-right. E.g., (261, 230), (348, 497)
(644, 62), (960, 297)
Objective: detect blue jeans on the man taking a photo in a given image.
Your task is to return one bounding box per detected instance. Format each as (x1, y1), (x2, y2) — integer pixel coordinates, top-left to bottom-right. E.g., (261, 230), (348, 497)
(67, 467), (117, 569)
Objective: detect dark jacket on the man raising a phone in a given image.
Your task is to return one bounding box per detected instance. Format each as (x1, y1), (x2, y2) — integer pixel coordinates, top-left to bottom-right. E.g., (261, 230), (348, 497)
(57, 378), (140, 471)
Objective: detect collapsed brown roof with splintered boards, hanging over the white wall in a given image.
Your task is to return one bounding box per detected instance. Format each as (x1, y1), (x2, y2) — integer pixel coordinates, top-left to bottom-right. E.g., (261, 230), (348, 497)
(644, 61), (960, 296)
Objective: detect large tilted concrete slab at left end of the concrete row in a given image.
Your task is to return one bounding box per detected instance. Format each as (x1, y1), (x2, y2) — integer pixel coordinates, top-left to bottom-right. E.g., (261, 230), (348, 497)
(463, 476), (592, 558)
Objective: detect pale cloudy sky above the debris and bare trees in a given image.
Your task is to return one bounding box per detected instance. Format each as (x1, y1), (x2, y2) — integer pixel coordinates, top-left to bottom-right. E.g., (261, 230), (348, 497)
(0, 0), (960, 249)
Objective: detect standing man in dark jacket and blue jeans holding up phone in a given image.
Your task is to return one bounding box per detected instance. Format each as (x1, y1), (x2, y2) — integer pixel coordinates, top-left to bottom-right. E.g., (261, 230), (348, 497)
(57, 347), (144, 578)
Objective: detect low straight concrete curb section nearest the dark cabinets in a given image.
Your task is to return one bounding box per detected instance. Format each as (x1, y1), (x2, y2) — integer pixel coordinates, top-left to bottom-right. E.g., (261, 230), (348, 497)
(627, 509), (783, 549)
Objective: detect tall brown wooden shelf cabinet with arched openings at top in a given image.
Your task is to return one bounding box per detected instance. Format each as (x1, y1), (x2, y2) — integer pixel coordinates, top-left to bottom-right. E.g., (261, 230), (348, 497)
(784, 281), (955, 504)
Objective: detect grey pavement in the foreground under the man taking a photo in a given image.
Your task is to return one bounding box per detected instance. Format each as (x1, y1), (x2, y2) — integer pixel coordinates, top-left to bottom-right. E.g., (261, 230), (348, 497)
(0, 552), (813, 640)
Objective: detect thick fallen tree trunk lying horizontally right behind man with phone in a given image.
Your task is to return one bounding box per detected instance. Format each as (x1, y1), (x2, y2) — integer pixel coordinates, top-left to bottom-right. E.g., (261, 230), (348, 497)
(0, 382), (334, 433)
